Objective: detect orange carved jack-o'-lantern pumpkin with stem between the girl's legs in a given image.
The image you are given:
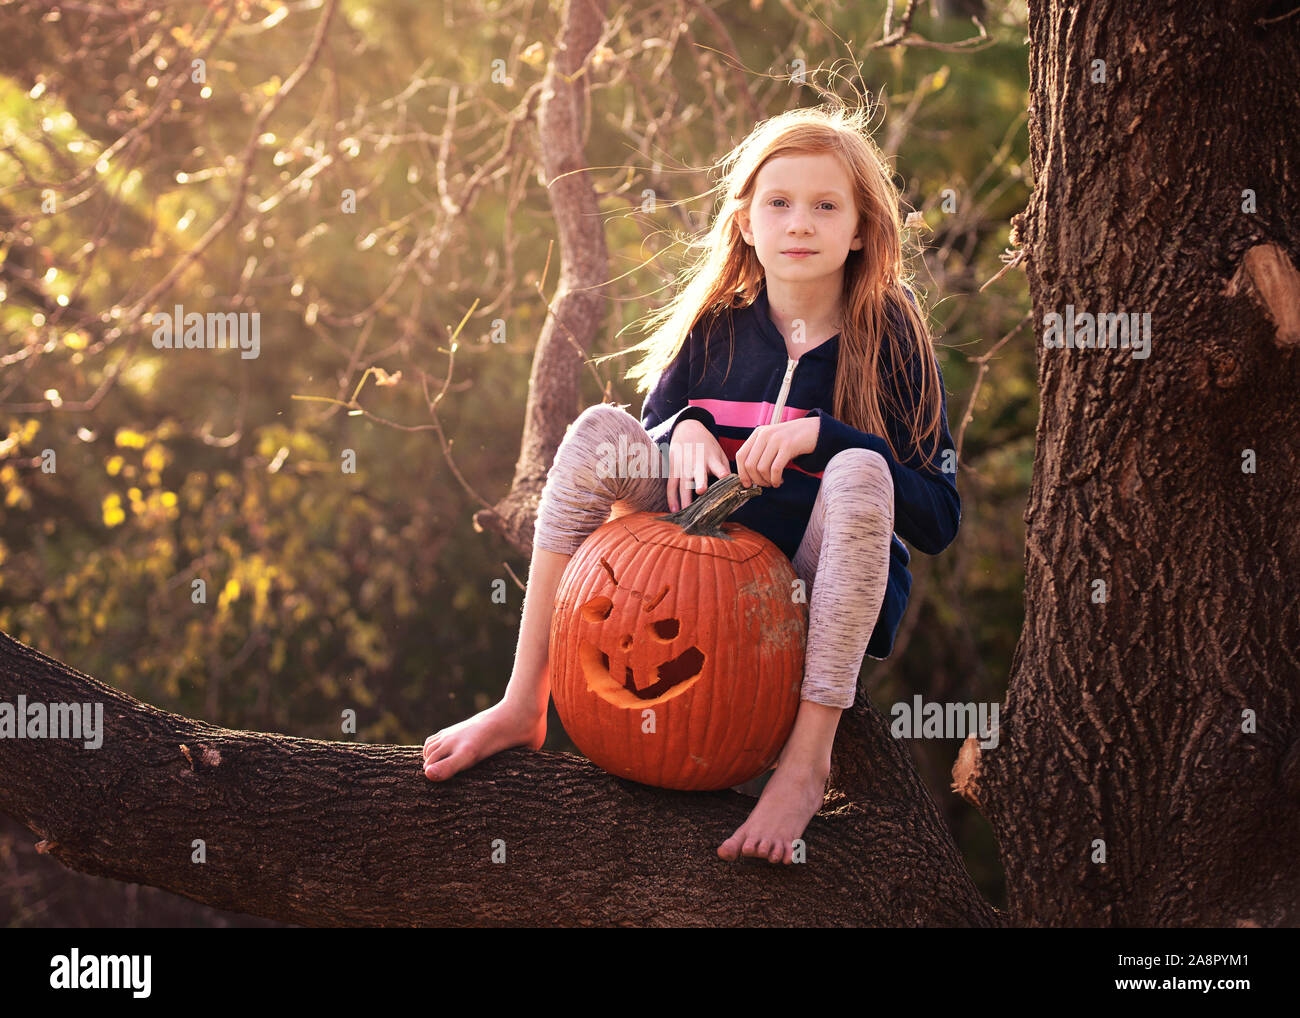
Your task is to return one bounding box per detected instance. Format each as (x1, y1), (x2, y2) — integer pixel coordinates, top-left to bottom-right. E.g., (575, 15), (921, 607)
(547, 475), (807, 789)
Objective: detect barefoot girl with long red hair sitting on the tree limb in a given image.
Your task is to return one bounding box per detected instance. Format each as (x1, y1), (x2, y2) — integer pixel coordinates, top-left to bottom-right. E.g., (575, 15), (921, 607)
(424, 108), (961, 863)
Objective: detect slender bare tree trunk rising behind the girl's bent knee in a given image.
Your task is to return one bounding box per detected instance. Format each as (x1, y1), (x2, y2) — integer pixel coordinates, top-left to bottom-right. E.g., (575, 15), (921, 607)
(473, 0), (610, 554)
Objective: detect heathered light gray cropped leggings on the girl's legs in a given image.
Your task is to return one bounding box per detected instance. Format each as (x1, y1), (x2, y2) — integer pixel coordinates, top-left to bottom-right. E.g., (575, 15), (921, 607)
(533, 403), (894, 709)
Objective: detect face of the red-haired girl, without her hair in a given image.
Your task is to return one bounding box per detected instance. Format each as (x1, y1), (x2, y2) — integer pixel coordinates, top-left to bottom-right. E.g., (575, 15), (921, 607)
(736, 153), (862, 283)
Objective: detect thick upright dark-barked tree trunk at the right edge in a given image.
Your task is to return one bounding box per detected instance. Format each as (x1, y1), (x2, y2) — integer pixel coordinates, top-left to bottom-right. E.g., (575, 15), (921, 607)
(954, 0), (1300, 926)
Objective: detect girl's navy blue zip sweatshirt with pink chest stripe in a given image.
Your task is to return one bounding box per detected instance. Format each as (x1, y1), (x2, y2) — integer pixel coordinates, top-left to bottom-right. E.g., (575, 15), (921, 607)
(641, 286), (962, 660)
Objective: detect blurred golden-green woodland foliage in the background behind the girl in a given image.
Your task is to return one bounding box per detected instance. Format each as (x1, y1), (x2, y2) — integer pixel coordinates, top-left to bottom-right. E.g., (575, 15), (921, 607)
(0, 0), (1037, 924)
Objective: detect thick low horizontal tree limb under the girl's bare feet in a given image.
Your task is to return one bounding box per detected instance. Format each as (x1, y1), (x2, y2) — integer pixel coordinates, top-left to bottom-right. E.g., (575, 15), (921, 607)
(0, 634), (1000, 926)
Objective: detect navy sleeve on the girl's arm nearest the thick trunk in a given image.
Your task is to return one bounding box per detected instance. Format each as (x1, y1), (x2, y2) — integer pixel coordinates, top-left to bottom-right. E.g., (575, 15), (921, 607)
(797, 315), (962, 555)
